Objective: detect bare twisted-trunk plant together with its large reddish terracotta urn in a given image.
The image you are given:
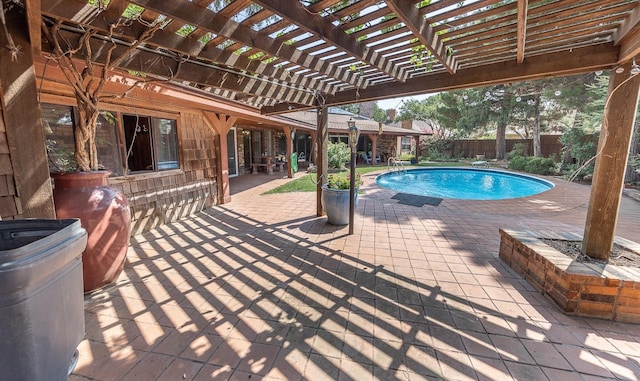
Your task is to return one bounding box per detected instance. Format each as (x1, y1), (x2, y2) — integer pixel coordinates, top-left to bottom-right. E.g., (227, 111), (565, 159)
(43, 14), (163, 292)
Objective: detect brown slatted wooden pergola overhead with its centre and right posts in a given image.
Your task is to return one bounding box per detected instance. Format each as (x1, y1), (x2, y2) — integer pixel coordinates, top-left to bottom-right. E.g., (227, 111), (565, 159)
(0, 0), (640, 256)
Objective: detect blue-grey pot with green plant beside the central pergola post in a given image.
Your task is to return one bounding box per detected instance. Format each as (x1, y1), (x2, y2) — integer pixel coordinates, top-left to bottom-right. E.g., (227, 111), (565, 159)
(321, 173), (362, 225)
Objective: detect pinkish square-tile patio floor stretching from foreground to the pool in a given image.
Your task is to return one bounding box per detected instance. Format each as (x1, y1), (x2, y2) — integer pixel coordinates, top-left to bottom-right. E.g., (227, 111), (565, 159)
(71, 169), (640, 381)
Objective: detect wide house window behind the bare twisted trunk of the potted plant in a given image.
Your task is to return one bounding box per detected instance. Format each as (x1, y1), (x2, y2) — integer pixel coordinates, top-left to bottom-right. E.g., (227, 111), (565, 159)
(42, 104), (180, 176)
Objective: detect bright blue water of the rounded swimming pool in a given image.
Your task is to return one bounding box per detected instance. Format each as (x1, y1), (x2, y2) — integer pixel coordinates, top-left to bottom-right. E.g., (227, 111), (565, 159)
(376, 168), (554, 200)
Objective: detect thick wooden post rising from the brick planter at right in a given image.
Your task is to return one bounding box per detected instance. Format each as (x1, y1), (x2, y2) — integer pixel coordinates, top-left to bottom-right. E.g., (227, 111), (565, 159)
(582, 63), (640, 259)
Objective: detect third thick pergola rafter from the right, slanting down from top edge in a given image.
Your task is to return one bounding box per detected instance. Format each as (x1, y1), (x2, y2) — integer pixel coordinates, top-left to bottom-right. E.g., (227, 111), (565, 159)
(254, 0), (403, 81)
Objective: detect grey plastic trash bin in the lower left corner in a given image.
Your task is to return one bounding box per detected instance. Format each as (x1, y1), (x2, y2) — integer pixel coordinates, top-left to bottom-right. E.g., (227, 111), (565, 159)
(0, 219), (87, 381)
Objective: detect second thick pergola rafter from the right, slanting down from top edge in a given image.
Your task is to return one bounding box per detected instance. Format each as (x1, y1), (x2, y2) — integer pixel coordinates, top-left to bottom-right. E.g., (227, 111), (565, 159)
(387, 0), (458, 74)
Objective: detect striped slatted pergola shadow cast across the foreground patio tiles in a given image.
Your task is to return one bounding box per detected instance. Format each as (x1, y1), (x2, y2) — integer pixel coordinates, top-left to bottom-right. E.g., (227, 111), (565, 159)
(76, 200), (640, 380)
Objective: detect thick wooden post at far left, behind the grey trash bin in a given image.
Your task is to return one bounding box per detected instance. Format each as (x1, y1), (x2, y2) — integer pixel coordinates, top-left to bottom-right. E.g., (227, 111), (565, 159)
(0, 10), (55, 218)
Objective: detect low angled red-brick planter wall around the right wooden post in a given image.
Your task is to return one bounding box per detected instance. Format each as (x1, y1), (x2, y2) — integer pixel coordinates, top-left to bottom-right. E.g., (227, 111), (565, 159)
(499, 229), (640, 324)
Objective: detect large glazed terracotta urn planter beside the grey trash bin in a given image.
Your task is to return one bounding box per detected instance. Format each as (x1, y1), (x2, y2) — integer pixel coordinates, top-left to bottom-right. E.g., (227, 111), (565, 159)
(52, 171), (131, 292)
